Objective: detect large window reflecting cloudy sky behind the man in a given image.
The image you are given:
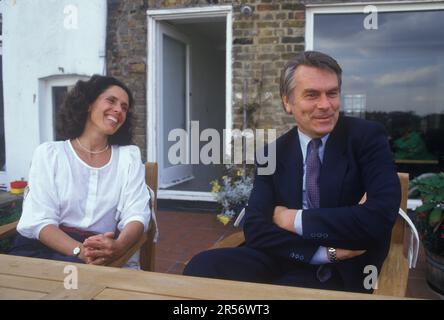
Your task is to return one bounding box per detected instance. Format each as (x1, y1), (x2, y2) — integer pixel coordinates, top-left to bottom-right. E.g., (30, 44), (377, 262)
(307, 5), (444, 176)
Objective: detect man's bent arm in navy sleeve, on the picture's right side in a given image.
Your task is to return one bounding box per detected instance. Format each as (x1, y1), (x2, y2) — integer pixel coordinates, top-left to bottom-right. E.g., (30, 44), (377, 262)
(302, 126), (401, 250)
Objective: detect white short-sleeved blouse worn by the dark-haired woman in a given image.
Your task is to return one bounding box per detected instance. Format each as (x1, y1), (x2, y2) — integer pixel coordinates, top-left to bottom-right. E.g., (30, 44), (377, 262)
(17, 140), (151, 239)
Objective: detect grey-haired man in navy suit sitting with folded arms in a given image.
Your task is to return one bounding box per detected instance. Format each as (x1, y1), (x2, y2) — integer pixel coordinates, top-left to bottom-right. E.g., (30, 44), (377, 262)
(184, 51), (400, 292)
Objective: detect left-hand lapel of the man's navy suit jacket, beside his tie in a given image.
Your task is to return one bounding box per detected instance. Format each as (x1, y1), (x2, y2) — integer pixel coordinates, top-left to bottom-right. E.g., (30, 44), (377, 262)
(278, 128), (303, 208)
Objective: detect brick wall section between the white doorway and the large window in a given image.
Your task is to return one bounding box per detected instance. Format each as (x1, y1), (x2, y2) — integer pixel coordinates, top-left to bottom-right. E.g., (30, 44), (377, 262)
(229, 0), (305, 135)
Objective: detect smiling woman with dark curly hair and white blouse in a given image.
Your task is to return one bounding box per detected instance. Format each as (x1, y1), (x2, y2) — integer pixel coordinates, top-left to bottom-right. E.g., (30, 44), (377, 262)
(10, 75), (151, 265)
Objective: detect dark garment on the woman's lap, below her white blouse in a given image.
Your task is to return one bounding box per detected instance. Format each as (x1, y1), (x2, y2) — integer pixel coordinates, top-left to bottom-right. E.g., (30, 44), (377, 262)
(8, 232), (87, 263)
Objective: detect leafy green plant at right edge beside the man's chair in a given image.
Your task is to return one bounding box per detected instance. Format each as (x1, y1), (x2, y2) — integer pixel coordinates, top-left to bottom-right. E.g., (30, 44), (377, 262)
(412, 172), (444, 257)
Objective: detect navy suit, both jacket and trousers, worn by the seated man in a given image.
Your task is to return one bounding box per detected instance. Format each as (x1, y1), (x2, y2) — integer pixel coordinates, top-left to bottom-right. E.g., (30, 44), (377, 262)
(184, 117), (401, 292)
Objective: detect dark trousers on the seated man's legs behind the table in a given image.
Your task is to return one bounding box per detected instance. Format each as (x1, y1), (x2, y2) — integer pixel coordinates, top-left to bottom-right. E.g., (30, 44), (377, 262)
(183, 246), (344, 290)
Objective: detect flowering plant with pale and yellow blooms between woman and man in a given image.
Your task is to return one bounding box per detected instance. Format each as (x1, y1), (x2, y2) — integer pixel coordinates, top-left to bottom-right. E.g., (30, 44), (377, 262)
(211, 165), (253, 225)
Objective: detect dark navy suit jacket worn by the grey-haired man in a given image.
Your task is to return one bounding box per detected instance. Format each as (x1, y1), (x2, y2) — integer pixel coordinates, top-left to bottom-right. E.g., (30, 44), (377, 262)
(244, 117), (401, 292)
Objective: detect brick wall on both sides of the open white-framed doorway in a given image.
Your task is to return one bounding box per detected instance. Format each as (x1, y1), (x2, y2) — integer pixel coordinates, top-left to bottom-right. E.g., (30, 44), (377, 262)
(107, 0), (305, 155)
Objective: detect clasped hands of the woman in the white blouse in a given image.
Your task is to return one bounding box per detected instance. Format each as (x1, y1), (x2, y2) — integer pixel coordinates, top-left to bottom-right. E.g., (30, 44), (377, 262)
(82, 232), (123, 265)
